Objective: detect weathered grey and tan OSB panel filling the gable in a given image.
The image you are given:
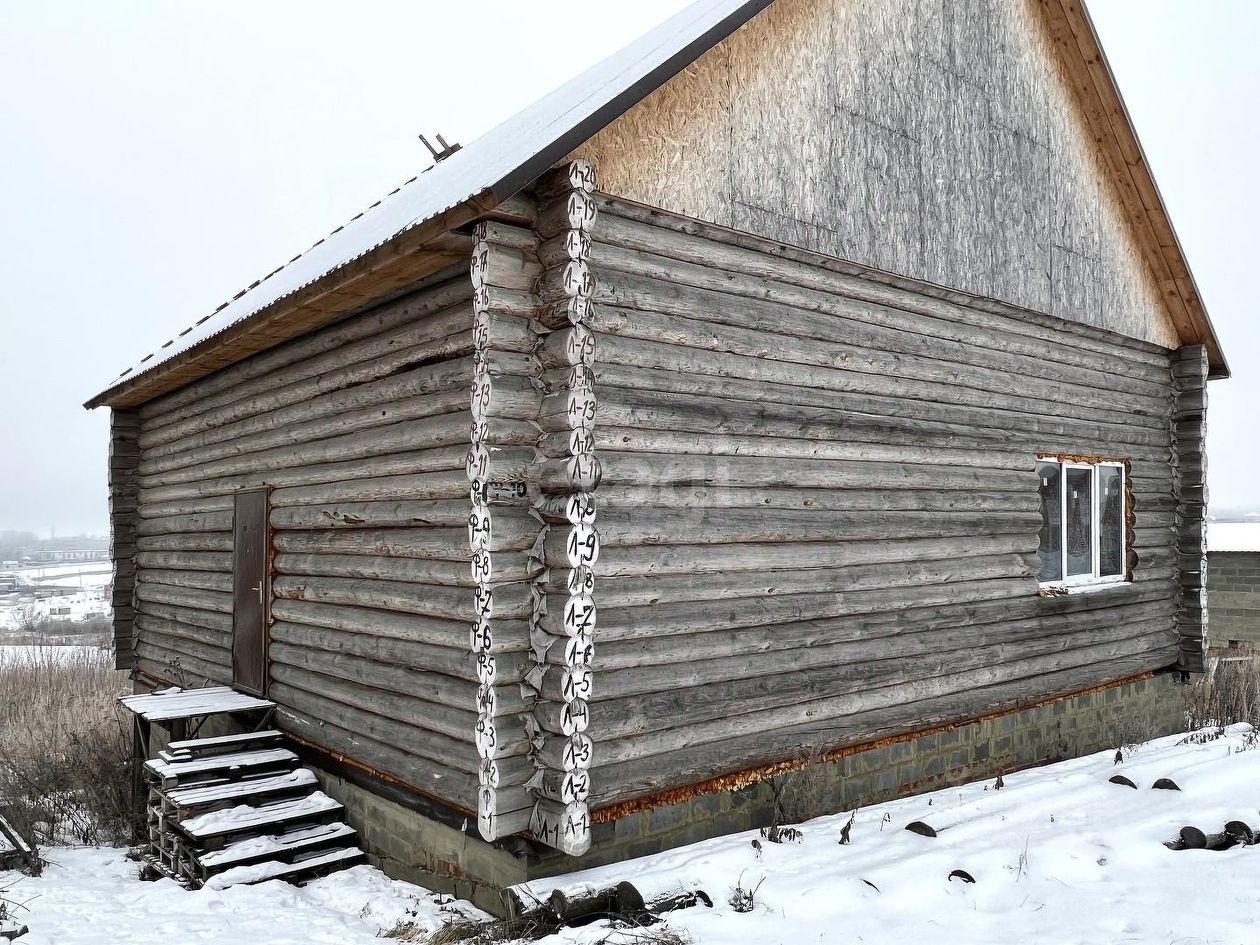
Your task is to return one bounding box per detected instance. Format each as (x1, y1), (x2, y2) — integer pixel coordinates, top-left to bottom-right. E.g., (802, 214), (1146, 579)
(577, 0), (1178, 348)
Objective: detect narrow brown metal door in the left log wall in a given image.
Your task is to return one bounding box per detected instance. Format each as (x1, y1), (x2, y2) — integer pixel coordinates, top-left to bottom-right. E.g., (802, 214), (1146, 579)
(232, 489), (271, 696)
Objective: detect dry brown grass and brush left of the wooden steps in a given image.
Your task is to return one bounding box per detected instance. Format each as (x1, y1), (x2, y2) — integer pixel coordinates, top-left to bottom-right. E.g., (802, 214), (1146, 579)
(0, 646), (140, 844)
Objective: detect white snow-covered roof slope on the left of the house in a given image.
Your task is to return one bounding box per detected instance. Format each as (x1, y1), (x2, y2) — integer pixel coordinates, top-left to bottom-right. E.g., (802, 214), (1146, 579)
(95, 0), (770, 399)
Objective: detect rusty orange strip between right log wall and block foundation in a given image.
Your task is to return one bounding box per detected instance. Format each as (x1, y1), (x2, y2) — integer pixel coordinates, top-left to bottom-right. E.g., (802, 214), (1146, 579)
(591, 672), (1155, 824)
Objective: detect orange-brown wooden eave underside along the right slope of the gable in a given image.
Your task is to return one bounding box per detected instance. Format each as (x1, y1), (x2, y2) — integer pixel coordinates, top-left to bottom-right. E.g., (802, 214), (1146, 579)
(1038, 0), (1230, 378)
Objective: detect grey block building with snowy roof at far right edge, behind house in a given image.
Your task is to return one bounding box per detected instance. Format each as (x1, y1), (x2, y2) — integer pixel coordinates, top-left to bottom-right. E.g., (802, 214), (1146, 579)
(1207, 522), (1260, 655)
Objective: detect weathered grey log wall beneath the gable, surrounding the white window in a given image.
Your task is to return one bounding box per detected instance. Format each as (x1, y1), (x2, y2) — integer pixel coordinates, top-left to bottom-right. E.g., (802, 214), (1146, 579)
(586, 198), (1184, 808)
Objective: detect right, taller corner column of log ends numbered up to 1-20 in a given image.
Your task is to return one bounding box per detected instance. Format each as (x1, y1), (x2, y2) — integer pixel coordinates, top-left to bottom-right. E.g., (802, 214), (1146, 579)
(525, 161), (600, 856)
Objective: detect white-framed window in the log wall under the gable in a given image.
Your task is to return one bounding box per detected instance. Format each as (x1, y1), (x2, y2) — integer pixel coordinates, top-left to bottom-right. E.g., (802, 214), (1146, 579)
(1037, 456), (1128, 587)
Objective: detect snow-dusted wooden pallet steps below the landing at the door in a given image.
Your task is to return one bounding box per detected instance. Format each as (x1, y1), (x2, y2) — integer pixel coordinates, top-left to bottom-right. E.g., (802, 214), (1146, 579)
(121, 697), (364, 888)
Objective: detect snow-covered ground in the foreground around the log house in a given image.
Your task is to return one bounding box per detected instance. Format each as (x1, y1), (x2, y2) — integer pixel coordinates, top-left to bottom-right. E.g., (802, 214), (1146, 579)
(0, 726), (1260, 945)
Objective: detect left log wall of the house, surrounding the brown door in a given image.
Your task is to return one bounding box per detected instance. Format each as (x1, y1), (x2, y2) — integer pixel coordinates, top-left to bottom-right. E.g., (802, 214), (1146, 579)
(130, 266), (488, 810)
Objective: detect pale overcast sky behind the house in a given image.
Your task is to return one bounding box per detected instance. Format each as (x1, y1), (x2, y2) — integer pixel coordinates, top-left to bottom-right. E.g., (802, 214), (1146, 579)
(0, 0), (1260, 534)
